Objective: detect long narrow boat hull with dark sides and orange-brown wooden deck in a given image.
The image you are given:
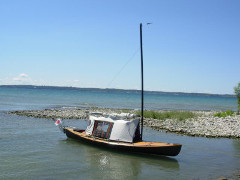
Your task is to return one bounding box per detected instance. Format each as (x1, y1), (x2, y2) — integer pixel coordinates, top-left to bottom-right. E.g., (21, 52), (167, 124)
(64, 128), (182, 156)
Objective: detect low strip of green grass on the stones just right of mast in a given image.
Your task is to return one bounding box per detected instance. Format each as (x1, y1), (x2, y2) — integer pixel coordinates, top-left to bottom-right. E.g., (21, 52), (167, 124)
(137, 111), (197, 121)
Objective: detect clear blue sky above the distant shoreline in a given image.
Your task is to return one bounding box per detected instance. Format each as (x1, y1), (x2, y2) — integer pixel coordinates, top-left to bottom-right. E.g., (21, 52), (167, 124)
(0, 0), (240, 94)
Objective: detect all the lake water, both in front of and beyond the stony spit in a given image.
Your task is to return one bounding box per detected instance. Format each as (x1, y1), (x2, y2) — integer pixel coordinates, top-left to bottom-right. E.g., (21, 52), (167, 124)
(0, 87), (240, 179)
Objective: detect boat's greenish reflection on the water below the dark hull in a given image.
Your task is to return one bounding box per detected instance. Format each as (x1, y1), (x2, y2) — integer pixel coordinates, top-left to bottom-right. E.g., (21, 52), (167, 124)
(62, 139), (179, 179)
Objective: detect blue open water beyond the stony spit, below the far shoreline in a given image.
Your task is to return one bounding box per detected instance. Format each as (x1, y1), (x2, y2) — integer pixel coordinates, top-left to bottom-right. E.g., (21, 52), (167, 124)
(0, 86), (237, 110)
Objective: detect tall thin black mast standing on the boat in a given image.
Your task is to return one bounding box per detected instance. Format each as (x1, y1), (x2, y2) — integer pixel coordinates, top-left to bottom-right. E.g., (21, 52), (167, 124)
(140, 23), (144, 140)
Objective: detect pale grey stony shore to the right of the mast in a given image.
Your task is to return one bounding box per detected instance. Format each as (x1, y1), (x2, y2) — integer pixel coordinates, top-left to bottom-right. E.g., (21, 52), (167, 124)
(145, 112), (240, 138)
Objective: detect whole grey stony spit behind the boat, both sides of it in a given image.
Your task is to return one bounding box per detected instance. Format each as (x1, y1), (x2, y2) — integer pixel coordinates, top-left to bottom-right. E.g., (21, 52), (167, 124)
(9, 108), (240, 138)
